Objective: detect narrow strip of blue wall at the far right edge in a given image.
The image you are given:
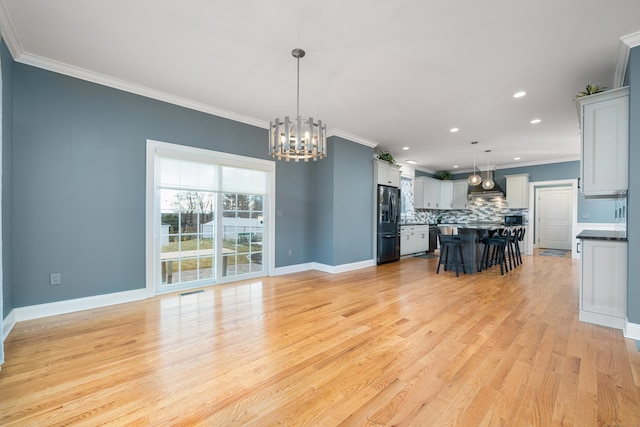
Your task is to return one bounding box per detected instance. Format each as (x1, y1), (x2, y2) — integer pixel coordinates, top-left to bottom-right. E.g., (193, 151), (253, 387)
(627, 47), (640, 324)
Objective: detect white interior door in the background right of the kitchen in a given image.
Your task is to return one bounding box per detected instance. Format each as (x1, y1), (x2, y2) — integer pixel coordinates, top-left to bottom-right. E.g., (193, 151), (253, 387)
(537, 187), (573, 250)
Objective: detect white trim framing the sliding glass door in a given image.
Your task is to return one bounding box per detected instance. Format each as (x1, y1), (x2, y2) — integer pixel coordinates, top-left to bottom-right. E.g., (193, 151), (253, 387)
(145, 139), (276, 298)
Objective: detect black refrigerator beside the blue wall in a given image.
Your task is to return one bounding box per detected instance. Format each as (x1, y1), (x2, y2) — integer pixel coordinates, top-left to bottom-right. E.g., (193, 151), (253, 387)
(376, 185), (400, 264)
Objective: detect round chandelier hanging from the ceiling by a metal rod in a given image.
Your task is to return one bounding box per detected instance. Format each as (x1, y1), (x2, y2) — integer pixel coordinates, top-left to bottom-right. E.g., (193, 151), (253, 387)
(269, 49), (327, 162)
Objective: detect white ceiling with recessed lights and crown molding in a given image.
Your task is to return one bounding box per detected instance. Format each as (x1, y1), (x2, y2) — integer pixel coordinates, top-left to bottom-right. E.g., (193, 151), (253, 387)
(0, 0), (640, 171)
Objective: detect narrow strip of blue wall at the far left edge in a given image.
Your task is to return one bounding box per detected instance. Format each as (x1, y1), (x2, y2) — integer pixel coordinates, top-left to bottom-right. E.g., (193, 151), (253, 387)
(0, 42), (13, 318)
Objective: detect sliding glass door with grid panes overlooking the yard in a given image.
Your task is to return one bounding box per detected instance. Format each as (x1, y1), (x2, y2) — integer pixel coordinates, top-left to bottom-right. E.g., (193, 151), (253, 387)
(147, 142), (273, 292)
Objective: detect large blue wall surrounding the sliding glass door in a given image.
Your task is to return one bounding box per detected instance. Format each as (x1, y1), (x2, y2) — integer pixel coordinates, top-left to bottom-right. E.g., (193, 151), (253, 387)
(10, 63), (328, 307)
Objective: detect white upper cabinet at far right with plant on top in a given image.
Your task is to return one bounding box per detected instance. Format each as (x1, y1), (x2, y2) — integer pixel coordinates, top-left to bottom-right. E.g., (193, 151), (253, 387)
(576, 87), (629, 196)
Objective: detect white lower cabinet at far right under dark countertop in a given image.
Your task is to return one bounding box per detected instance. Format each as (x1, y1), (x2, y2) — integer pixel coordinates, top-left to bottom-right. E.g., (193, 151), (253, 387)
(579, 239), (627, 329)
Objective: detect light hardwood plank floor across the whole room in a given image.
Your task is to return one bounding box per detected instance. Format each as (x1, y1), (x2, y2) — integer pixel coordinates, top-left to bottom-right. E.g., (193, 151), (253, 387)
(0, 256), (640, 426)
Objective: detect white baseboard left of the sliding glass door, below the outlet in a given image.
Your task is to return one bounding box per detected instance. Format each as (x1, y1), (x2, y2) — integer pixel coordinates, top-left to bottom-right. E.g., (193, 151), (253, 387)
(13, 289), (147, 322)
